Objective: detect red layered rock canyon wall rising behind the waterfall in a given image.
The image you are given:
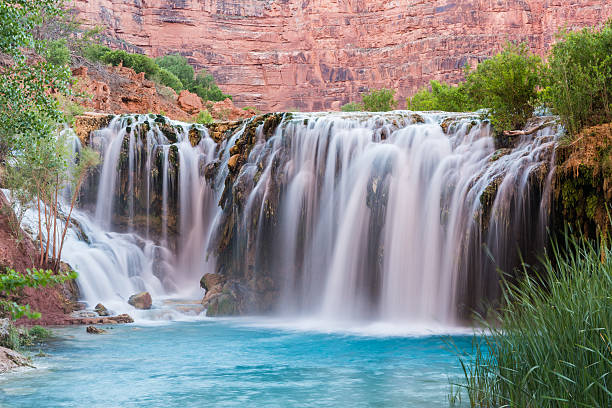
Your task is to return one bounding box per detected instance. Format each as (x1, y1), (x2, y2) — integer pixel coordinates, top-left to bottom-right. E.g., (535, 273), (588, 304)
(72, 0), (612, 111)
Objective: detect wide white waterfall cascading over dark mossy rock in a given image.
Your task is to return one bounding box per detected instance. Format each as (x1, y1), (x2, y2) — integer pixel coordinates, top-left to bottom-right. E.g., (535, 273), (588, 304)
(41, 112), (557, 323)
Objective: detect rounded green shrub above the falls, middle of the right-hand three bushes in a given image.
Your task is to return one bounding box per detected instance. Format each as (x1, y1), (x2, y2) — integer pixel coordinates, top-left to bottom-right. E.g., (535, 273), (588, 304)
(466, 43), (543, 131)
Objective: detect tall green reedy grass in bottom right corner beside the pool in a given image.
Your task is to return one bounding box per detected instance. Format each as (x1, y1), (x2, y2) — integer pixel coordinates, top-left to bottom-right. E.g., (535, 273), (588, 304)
(461, 233), (612, 408)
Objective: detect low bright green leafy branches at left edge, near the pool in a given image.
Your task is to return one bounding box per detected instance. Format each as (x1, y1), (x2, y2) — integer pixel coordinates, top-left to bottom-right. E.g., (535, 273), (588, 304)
(0, 268), (77, 319)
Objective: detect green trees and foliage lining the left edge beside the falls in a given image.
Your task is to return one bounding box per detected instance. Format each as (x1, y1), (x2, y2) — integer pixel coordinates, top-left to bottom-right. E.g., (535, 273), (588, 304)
(0, 0), (84, 326)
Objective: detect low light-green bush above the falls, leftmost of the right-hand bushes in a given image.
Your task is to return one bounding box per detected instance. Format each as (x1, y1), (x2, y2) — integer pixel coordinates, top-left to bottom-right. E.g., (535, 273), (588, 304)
(406, 81), (481, 112)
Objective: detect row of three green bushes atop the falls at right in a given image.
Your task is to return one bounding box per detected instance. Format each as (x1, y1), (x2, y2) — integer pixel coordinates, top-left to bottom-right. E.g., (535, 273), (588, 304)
(406, 20), (612, 138)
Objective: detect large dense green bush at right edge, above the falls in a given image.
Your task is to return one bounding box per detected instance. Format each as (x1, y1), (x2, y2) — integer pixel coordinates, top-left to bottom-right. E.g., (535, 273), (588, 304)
(544, 20), (612, 135)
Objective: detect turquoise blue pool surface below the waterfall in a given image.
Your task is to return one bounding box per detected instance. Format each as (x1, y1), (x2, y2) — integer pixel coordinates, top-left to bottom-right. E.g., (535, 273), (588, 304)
(0, 319), (471, 407)
